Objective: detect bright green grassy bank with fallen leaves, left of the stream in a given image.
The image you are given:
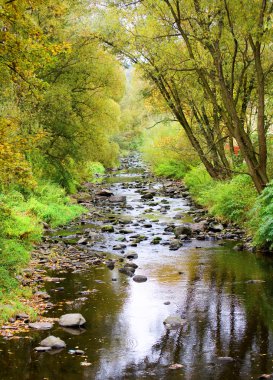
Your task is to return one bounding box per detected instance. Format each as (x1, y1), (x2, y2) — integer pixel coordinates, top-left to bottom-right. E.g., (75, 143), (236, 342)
(0, 182), (85, 321)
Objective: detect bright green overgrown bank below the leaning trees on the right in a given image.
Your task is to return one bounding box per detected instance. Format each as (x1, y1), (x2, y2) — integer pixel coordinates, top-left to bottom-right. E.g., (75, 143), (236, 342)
(148, 151), (273, 251)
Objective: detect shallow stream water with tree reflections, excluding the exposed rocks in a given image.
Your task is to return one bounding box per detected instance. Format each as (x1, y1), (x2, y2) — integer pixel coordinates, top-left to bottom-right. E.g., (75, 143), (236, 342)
(0, 156), (273, 380)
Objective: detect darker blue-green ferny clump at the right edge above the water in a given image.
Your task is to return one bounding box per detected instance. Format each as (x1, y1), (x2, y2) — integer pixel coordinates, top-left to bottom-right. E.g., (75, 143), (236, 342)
(248, 181), (273, 250)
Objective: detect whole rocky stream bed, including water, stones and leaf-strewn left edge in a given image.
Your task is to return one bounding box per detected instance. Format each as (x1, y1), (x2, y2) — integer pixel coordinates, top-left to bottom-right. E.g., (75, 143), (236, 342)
(0, 156), (273, 380)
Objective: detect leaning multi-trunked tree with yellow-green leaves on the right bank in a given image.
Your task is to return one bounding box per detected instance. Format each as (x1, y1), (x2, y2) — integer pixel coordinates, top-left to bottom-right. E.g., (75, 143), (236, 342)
(93, 0), (272, 191)
